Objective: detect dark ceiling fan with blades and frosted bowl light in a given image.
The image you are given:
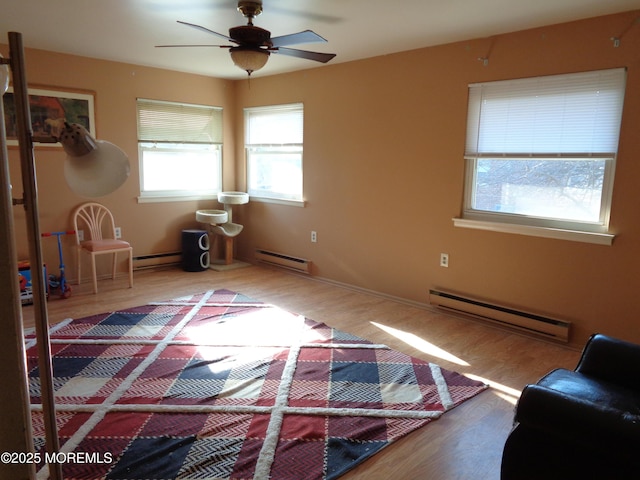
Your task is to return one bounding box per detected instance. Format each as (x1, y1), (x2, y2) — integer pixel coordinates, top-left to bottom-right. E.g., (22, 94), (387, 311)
(157, 0), (336, 76)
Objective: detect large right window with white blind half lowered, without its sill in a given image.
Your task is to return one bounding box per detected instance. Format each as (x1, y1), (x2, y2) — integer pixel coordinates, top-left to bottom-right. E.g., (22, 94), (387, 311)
(463, 69), (626, 244)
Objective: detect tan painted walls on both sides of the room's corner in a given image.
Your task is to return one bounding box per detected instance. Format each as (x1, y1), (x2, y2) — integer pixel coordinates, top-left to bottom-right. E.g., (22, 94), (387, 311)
(0, 11), (640, 344)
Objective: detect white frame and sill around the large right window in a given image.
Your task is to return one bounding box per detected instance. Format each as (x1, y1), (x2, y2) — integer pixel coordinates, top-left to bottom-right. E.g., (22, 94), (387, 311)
(453, 68), (626, 245)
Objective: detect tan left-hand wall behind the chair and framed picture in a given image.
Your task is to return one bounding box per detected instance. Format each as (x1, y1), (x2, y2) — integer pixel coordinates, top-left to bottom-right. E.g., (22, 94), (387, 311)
(2, 42), (235, 278)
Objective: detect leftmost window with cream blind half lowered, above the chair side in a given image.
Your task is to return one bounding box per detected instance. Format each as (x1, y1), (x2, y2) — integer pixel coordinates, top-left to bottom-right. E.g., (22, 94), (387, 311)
(137, 99), (222, 201)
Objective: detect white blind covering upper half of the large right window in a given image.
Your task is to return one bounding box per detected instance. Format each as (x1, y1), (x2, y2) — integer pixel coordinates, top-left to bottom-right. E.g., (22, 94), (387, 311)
(465, 68), (626, 158)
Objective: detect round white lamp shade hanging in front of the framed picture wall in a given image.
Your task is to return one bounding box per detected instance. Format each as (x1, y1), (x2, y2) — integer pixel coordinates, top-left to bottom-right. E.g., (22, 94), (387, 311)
(64, 140), (130, 198)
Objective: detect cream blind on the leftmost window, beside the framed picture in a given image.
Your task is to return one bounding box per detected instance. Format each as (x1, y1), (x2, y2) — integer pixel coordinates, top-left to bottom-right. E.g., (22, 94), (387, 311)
(138, 99), (222, 144)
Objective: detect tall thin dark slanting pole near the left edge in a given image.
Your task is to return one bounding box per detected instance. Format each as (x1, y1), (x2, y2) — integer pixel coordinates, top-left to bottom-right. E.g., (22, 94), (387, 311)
(9, 32), (62, 480)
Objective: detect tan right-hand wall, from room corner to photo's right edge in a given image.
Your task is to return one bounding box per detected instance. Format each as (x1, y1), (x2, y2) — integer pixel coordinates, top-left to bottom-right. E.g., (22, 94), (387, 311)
(234, 12), (640, 343)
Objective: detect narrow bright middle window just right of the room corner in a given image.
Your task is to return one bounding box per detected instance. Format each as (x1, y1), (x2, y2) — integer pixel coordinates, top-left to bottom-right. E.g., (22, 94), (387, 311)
(244, 103), (304, 202)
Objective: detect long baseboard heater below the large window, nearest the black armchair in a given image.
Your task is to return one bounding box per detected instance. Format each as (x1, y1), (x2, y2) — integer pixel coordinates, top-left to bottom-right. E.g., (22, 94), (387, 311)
(429, 290), (571, 343)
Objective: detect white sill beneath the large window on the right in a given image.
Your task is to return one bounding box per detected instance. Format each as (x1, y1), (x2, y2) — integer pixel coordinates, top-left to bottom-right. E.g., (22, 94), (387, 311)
(453, 218), (615, 246)
